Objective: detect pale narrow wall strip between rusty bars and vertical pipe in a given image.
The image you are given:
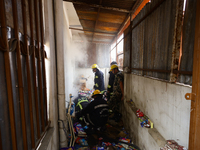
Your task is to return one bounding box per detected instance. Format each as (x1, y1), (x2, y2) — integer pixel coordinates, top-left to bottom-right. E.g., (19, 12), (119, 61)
(44, 0), (59, 149)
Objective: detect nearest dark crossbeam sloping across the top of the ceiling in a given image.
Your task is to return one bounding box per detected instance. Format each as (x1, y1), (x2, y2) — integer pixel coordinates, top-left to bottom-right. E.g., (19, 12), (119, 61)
(63, 0), (130, 13)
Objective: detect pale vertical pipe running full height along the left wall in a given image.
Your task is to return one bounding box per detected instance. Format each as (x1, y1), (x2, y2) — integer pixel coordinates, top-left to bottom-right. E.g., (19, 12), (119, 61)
(53, 0), (68, 148)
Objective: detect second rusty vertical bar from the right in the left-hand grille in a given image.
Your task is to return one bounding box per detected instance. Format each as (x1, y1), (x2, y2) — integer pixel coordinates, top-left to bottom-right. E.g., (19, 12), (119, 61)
(34, 0), (45, 131)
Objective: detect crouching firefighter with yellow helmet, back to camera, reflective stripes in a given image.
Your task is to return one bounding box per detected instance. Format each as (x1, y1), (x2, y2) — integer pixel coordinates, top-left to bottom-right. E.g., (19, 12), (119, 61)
(81, 90), (109, 129)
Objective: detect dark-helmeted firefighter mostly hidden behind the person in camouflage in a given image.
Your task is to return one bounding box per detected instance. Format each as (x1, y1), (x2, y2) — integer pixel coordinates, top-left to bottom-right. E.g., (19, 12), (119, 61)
(107, 61), (117, 101)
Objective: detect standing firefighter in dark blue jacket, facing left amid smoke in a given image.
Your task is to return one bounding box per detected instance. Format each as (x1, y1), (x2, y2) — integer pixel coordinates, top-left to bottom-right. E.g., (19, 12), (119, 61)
(92, 64), (105, 91)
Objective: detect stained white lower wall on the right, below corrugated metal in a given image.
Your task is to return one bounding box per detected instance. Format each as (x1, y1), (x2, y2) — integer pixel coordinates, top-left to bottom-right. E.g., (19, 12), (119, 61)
(124, 74), (191, 150)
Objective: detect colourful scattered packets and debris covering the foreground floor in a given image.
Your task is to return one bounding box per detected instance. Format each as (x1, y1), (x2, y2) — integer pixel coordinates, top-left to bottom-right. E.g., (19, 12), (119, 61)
(61, 118), (140, 150)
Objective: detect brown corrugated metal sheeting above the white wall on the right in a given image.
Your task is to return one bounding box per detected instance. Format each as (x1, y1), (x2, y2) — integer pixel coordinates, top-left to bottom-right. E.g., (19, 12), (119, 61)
(124, 0), (195, 84)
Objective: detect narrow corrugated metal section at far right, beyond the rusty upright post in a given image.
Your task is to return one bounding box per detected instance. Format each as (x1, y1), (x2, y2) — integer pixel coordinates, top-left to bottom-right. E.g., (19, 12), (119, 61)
(179, 0), (197, 85)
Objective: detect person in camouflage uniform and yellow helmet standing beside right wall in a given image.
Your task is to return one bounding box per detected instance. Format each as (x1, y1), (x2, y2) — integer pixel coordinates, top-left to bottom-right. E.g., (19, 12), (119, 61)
(108, 64), (124, 121)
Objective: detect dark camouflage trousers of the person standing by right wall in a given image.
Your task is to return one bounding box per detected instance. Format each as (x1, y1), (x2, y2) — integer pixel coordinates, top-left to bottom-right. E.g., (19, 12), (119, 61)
(108, 94), (122, 112)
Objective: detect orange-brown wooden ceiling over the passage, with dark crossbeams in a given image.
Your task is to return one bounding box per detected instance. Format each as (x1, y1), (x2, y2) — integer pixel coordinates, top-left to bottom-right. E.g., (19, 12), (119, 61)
(63, 0), (142, 44)
